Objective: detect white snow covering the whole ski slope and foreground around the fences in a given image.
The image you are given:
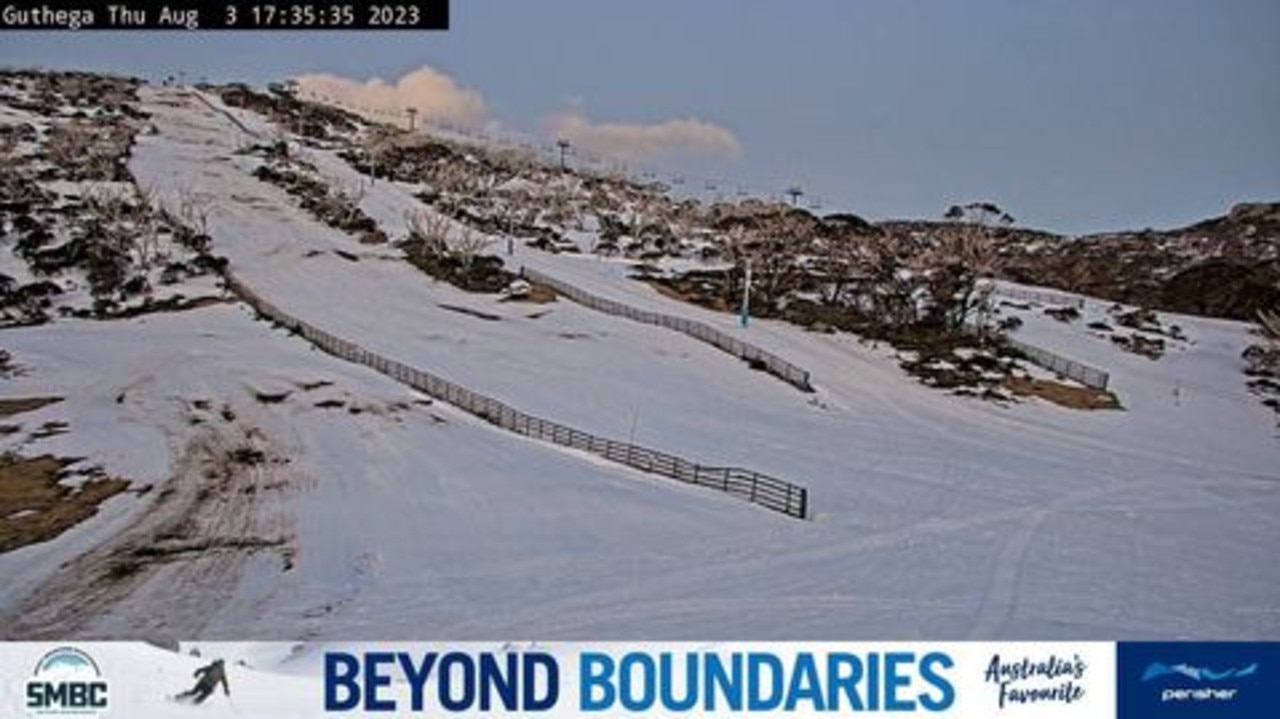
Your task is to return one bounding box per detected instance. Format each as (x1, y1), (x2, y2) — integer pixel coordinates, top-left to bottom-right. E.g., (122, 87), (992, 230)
(0, 83), (1280, 640)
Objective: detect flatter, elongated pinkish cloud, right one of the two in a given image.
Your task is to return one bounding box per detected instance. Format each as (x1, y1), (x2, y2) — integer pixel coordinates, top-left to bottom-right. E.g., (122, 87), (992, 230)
(548, 113), (742, 161)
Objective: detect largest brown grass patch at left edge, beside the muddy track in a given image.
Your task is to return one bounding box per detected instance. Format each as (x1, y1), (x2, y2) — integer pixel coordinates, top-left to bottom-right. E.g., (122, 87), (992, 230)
(0, 454), (129, 554)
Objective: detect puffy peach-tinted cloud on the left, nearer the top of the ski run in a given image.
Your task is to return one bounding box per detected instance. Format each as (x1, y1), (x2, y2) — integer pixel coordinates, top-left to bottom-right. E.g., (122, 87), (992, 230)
(296, 65), (489, 127)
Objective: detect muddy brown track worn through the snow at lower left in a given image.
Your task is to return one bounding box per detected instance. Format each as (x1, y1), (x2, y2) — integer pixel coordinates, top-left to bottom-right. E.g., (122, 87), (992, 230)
(0, 409), (294, 640)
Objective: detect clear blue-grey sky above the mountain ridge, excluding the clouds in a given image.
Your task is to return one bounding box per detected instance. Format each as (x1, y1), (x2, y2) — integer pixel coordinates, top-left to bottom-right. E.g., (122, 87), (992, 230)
(0, 0), (1280, 233)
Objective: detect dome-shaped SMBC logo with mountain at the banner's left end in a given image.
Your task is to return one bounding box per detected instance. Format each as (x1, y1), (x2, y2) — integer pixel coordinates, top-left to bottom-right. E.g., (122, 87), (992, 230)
(26, 646), (108, 716)
